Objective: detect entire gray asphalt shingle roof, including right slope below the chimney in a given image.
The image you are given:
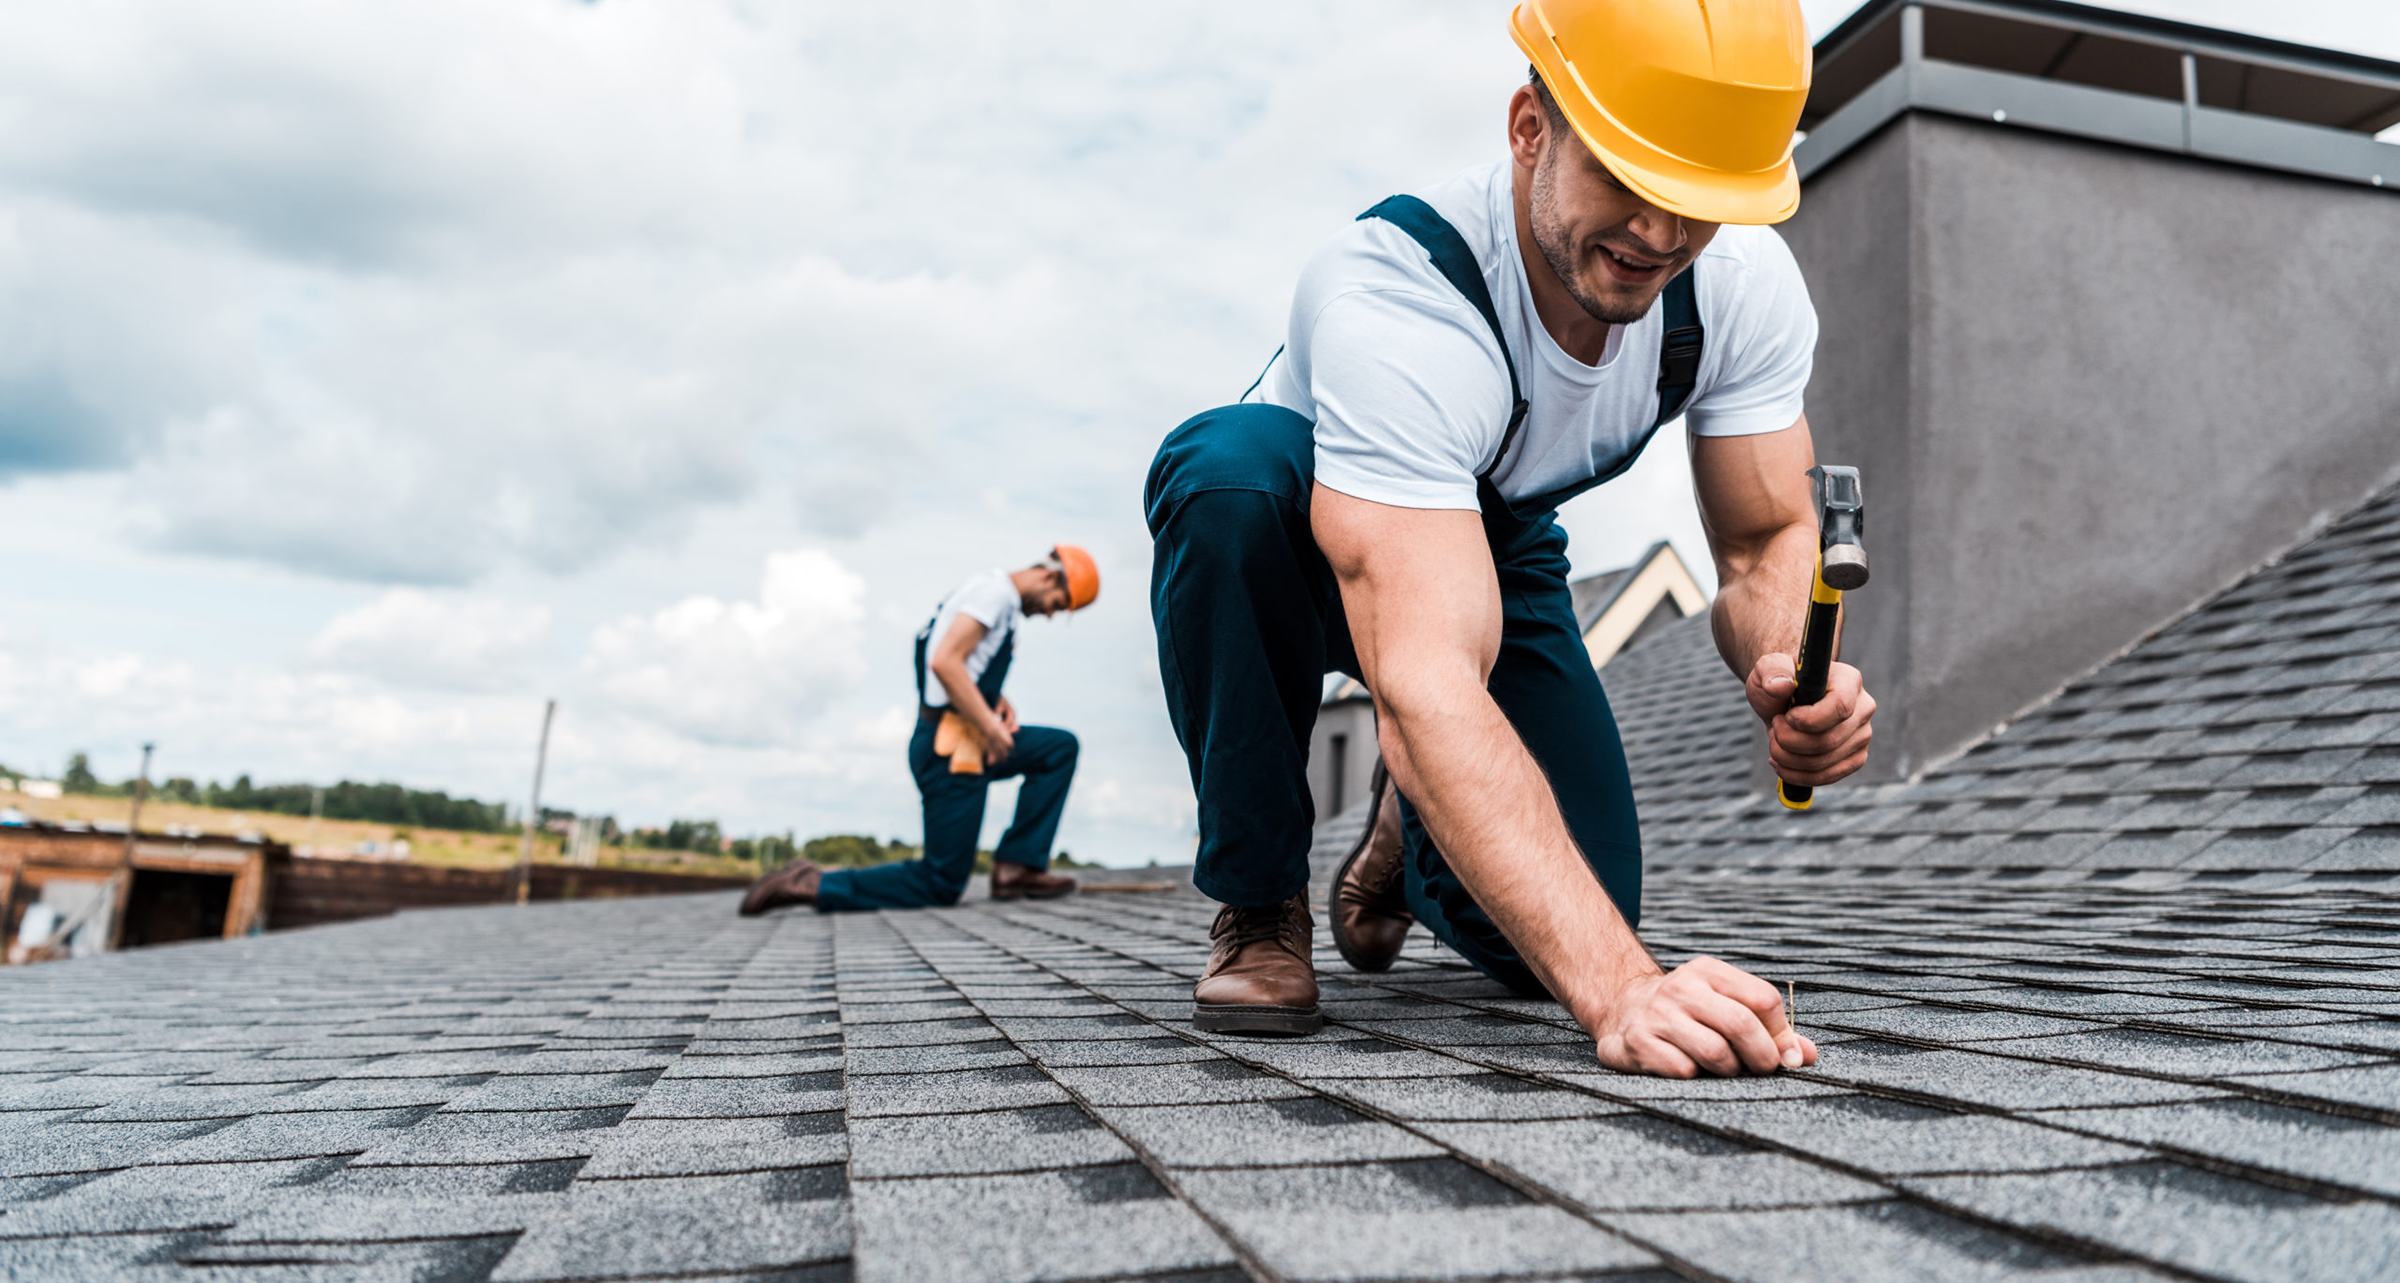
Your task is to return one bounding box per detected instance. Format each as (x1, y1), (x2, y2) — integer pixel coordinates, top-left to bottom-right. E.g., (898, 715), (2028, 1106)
(0, 486), (2400, 1281)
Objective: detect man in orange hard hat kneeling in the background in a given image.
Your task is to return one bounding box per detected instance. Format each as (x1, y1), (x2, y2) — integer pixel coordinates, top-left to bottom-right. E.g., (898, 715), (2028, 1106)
(742, 544), (1099, 916)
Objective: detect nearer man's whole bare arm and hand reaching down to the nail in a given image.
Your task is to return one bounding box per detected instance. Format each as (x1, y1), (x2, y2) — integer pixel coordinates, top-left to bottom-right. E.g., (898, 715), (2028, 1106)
(1310, 487), (1817, 1077)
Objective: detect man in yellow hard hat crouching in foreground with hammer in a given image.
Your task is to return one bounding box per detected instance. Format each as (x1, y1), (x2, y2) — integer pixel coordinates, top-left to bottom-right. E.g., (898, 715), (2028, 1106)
(1145, 0), (1874, 1074)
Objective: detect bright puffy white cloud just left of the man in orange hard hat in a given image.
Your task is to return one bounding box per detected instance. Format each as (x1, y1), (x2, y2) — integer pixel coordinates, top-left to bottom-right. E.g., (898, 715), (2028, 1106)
(583, 549), (866, 746)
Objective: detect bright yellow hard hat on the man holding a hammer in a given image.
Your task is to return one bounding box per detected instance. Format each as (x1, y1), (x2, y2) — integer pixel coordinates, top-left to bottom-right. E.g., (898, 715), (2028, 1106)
(1510, 0), (1810, 223)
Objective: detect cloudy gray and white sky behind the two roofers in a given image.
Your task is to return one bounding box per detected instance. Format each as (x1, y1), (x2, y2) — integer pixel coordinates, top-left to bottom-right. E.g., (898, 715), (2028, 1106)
(0, 0), (2400, 863)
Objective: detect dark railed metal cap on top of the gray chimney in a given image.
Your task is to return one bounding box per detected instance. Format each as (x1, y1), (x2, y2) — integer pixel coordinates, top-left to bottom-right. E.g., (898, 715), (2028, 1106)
(1795, 0), (2400, 187)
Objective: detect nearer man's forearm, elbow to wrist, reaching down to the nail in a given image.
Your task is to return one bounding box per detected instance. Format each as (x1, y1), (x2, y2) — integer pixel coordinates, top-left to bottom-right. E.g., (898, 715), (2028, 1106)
(1380, 679), (1658, 1029)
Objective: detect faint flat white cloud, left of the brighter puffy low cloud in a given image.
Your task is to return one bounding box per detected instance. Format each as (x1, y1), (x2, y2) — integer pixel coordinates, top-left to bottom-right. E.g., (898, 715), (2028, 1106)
(305, 588), (550, 691)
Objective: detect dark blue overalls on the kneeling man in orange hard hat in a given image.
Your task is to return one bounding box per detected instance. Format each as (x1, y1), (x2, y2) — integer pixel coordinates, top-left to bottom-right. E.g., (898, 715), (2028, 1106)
(816, 612), (1078, 914)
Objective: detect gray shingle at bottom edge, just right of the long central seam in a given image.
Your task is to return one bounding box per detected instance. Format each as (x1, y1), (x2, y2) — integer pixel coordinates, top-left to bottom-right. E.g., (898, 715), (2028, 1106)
(852, 1165), (1234, 1283)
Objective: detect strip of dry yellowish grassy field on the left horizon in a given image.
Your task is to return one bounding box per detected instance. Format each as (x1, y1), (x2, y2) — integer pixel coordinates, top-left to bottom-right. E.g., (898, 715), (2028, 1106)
(0, 791), (758, 878)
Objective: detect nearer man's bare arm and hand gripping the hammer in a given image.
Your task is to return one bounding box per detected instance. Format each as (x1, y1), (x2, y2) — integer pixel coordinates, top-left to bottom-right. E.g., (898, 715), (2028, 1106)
(1692, 415), (1874, 787)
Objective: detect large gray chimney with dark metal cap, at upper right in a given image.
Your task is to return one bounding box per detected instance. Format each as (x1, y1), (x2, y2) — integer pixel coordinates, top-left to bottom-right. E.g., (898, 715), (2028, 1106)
(1783, 0), (2400, 779)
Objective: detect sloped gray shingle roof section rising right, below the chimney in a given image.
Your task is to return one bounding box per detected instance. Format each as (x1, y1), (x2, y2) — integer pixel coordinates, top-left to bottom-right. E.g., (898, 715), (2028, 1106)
(1601, 477), (2400, 885)
